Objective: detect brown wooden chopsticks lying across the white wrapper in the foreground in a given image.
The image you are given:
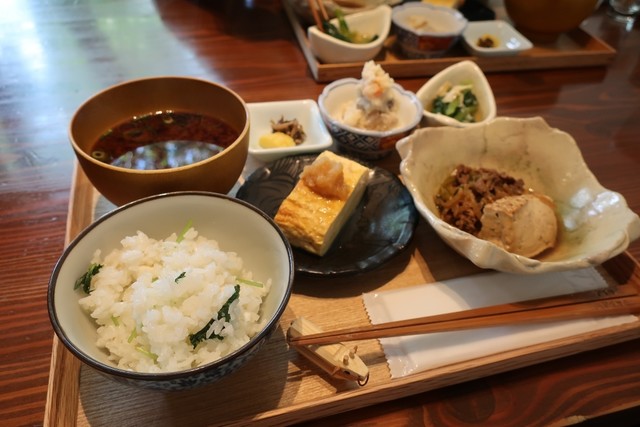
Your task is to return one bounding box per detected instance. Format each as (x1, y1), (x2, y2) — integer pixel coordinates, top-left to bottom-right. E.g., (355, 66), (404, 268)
(288, 285), (640, 345)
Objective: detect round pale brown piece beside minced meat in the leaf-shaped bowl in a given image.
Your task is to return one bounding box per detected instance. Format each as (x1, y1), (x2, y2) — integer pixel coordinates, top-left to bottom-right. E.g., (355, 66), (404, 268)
(478, 194), (558, 257)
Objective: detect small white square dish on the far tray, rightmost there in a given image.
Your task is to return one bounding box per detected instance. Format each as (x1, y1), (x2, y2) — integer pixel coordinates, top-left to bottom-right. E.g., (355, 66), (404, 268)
(462, 20), (533, 56)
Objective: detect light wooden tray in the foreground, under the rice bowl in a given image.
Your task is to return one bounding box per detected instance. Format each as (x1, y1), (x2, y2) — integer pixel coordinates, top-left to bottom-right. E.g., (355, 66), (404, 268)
(44, 168), (640, 426)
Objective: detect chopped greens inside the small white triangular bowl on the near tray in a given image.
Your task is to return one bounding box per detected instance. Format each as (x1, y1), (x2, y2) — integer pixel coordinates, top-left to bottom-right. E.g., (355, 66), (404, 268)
(431, 84), (479, 123)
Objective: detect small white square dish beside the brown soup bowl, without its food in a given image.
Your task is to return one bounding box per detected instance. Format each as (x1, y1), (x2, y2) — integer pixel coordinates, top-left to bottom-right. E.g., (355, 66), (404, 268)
(247, 99), (333, 162)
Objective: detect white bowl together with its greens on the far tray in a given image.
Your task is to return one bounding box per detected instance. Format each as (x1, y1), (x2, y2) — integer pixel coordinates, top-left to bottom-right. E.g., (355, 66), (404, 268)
(307, 5), (391, 64)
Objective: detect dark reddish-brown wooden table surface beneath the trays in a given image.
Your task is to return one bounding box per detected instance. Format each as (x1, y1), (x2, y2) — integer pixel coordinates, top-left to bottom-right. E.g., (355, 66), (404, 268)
(0, 0), (640, 426)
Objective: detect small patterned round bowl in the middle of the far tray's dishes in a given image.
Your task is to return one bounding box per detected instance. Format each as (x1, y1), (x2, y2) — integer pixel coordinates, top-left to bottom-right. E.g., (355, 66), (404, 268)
(391, 2), (468, 59)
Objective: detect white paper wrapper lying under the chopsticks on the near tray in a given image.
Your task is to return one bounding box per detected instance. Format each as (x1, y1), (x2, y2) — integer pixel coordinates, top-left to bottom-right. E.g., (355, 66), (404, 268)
(363, 268), (638, 378)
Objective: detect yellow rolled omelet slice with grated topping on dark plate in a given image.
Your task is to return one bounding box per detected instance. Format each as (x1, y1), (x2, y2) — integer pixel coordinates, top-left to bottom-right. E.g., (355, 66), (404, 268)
(274, 151), (371, 256)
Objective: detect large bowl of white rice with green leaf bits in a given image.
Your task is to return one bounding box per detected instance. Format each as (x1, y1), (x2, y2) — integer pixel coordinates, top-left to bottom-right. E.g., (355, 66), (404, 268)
(47, 191), (294, 390)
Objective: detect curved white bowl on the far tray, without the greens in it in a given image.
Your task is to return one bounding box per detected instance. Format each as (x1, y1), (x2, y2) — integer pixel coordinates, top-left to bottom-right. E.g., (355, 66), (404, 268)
(307, 5), (391, 64)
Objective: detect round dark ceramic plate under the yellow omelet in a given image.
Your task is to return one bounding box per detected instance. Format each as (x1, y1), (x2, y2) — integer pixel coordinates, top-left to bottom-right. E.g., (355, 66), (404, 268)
(236, 154), (419, 276)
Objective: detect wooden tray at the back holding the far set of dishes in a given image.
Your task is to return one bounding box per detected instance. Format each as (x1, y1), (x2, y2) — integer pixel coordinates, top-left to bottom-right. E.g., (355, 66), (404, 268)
(283, 1), (616, 82)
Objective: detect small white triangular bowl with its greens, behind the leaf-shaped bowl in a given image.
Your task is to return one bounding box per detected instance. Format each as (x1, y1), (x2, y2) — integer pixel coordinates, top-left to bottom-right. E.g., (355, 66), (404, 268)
(416, 61), (496, 127)
